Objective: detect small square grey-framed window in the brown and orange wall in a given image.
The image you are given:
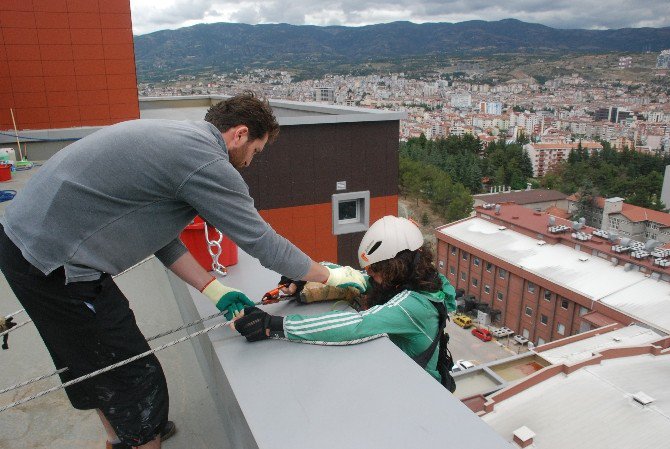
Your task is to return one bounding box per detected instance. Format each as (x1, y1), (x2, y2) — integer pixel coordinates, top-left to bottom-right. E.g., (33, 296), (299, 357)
(332, 190), (370, 235)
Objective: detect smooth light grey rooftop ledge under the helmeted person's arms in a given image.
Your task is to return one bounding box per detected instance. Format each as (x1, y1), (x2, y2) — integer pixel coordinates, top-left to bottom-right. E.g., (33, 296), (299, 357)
(175, 253), (508, 449)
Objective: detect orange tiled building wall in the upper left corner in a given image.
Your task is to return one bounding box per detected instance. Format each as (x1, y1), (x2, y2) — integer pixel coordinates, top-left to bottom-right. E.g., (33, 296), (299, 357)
(0, 0), (139, 130)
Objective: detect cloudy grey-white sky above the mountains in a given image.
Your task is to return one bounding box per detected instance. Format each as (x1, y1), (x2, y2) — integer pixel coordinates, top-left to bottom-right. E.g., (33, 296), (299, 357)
(130, 0), (670, 34)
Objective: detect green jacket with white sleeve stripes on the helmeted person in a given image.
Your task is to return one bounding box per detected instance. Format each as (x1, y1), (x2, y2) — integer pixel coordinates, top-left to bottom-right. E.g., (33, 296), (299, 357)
(284, 275), (456, 381)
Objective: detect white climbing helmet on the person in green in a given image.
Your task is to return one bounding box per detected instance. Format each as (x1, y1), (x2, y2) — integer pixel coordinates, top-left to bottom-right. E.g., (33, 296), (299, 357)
(358, 215), (423, 268)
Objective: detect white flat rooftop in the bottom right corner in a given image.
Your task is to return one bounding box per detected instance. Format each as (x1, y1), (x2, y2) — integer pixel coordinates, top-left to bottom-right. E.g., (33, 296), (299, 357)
(482, 355), (670, 449)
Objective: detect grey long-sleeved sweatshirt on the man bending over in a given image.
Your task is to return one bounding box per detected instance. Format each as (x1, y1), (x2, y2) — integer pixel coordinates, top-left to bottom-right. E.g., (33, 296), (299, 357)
(3, 120), (311, 282)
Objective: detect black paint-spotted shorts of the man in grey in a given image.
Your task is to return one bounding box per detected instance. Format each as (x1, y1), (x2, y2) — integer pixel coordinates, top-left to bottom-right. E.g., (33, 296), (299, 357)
(0, 226), (169, 446)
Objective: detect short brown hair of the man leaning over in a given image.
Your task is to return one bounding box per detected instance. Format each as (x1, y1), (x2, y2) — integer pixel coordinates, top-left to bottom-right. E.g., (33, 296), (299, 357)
(205, 90), (279, 143)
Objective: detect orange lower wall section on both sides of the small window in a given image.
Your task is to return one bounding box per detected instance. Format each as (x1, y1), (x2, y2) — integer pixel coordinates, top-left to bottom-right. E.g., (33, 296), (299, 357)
(260, 195), (398, 262)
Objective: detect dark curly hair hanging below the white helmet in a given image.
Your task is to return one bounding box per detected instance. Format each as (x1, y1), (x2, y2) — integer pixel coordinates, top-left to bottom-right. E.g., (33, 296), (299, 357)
(366, 244), (442, 307)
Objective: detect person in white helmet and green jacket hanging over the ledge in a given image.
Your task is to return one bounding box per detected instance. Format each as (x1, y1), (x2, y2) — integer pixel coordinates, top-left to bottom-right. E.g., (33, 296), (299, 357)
(234, 216), (456, 391)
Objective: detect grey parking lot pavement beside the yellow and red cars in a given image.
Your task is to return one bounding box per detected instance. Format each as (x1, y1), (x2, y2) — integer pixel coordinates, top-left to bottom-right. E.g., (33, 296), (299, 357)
(447, 321), (528, 365)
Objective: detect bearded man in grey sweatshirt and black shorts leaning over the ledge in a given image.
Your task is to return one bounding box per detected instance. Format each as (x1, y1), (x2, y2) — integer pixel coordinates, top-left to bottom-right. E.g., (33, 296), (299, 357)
(0, 92), (365, 449)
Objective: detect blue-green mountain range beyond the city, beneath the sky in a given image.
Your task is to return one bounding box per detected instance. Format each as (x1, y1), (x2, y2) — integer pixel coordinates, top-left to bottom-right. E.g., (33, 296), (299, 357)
(135, 19), (670, 81)
